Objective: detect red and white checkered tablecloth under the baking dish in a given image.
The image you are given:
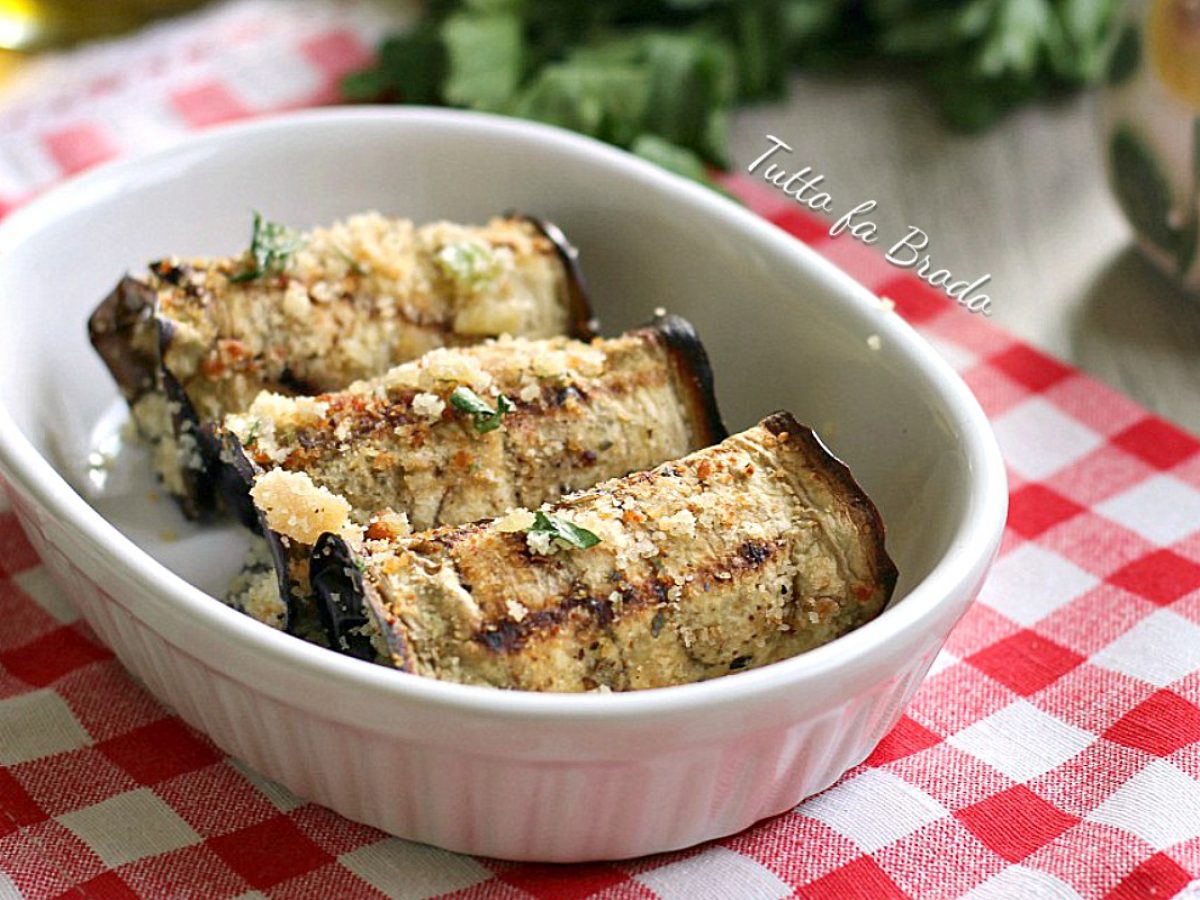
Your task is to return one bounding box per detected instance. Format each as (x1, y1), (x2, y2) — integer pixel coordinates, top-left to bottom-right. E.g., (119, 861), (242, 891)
(0, 0), (1200, 900)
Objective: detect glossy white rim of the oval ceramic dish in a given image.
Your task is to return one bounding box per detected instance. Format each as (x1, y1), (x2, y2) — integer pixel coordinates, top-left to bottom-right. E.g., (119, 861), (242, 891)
(0, 107), (1008, 720)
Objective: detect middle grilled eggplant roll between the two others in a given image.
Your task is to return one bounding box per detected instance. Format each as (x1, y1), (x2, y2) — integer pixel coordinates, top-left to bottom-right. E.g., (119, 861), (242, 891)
(230, 316), (725, 640)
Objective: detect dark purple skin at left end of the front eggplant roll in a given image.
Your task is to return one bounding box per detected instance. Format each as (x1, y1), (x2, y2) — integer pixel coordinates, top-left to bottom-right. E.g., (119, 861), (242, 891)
(308, 533), (376, 660)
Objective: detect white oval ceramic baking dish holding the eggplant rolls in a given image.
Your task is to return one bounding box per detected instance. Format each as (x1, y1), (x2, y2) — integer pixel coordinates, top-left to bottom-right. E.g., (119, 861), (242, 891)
(0, 109), (1007, 860)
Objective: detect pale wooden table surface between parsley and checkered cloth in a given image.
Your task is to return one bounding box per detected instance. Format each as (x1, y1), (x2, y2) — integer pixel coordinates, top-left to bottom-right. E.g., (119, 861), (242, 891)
(733, 74), (1200, 432)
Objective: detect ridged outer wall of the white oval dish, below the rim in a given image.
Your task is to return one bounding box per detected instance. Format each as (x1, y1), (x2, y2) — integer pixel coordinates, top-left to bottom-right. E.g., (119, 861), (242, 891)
(11, 482), (973, 862)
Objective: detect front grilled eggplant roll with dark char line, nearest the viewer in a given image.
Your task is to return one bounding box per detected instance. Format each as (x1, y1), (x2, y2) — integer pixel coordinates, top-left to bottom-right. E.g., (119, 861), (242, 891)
(311, 413), (896, 691)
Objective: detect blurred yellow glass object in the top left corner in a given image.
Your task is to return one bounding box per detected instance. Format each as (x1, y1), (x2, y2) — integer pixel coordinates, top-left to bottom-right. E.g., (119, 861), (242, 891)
(0, 0), (203, 52)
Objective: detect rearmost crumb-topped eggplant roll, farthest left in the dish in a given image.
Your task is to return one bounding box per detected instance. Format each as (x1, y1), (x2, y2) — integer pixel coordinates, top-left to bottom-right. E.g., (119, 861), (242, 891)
(89, 212), (592, 517)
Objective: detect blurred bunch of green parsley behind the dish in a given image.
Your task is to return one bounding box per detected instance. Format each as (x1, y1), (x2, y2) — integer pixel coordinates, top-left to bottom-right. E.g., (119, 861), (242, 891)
(343, 0), (1118, 180)
